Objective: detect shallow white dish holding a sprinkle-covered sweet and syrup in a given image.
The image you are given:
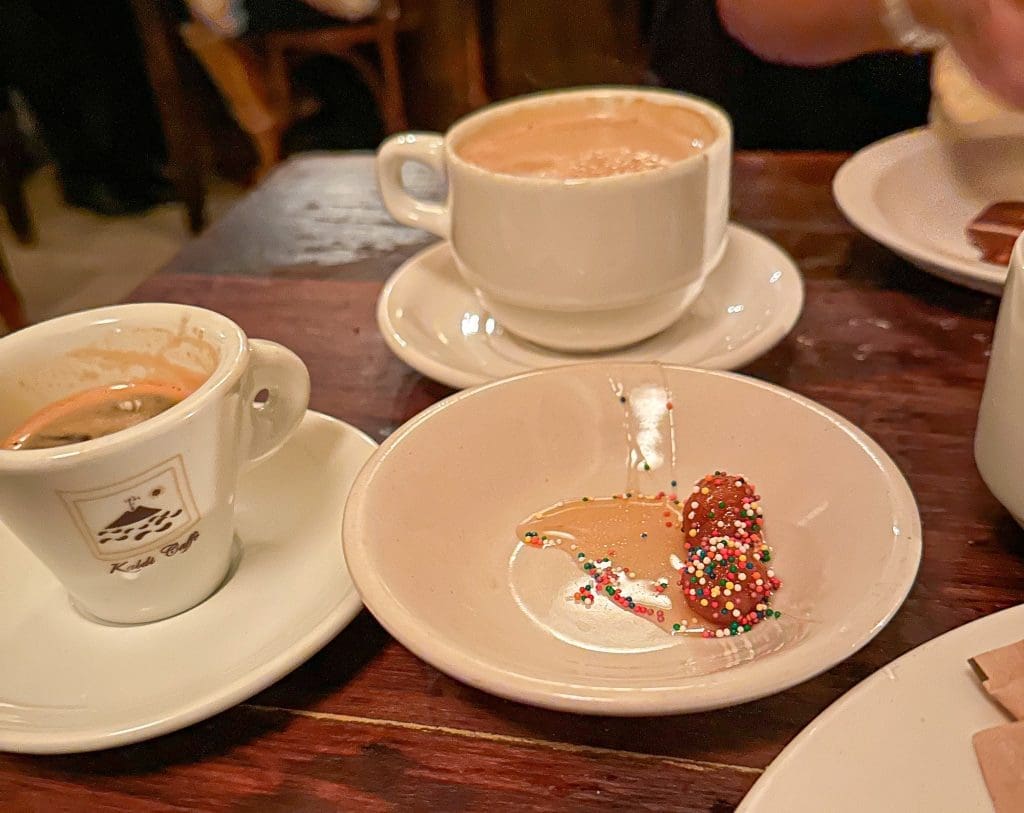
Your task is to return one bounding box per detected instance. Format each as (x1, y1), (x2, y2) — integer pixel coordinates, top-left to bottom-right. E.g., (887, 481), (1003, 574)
(345, 362), (921, 715)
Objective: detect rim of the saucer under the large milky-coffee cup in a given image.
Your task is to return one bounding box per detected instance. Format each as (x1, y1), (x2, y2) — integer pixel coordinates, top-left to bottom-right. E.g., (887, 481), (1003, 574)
(376, 220), (806, 389)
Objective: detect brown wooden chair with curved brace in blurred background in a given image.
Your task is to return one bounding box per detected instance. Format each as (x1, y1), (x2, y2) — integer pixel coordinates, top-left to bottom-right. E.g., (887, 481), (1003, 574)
(181, 0), (407, 176)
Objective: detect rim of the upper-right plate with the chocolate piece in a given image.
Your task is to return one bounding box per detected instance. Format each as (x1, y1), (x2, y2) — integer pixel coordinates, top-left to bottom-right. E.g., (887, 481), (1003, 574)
(831, 126), (1007, 295)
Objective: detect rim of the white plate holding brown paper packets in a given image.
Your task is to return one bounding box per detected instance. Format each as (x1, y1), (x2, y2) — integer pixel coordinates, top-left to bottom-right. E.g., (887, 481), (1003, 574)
(736, 604), (1024, 813)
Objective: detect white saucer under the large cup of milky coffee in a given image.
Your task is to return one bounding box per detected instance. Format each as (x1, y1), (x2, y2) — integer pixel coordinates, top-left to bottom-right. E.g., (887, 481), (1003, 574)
(377, 223), (804, 388)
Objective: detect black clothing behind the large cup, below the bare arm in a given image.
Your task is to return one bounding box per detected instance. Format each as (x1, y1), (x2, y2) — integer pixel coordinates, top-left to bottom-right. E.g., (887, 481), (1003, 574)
(648, 0), (931, 149)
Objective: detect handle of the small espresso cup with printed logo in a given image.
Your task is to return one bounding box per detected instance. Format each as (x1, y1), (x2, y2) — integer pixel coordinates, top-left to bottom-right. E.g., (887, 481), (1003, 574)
(242, 339), (309, 466)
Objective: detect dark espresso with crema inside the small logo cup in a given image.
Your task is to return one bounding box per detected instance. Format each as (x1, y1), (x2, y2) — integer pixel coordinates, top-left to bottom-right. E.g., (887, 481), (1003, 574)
(0, 381), (193, 450)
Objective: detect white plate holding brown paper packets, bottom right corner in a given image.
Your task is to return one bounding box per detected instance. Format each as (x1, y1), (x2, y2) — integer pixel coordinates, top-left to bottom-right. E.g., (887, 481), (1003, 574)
(739, 605), (1024, 813)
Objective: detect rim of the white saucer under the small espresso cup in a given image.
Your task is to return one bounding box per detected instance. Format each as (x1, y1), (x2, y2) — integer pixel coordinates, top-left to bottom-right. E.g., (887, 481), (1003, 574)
(0, 410), (379, 755)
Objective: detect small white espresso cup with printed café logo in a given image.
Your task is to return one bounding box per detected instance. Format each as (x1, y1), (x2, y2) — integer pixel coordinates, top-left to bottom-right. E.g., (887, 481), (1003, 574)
(0, 304), (309, 624)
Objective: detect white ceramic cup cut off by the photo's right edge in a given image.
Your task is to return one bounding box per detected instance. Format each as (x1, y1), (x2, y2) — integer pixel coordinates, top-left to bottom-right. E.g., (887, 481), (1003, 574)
(974, 228), (1024, 525)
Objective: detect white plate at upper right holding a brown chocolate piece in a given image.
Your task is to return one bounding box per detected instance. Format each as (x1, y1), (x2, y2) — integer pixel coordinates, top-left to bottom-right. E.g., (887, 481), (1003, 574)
(833, 128), (1007, 294)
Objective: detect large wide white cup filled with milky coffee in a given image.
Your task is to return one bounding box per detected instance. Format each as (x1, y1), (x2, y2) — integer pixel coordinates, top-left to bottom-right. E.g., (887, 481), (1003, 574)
(377, 88), (732, 351)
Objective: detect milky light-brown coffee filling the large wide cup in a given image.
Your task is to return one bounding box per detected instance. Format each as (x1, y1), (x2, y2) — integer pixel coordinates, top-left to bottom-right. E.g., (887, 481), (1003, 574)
(456, 96), (717, 179)
